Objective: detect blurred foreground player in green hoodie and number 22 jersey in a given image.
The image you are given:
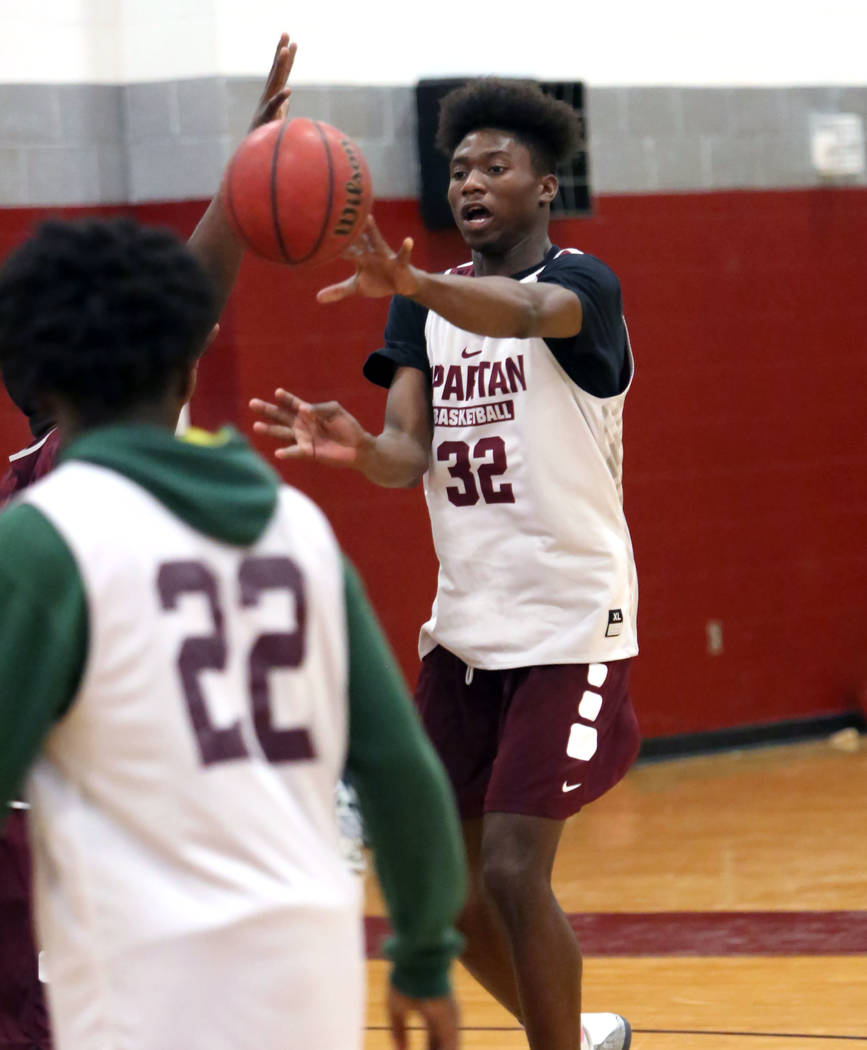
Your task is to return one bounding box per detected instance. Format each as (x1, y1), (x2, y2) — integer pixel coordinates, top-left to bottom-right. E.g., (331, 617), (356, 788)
(0, 221), (464, 1050)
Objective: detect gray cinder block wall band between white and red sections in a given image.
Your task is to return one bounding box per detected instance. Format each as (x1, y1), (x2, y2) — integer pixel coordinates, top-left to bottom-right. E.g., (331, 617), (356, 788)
(0, 77), (867, 207)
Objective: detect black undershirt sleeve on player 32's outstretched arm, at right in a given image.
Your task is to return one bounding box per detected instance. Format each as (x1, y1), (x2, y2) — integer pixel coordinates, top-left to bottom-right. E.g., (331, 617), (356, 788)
(538, 252), (630, 398)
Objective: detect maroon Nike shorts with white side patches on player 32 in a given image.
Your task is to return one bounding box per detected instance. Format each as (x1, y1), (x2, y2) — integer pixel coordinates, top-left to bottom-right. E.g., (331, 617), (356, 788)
(416, 646), (640, 820)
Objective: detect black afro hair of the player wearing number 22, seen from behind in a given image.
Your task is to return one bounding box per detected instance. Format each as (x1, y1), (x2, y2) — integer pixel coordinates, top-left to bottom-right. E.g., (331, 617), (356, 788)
(0, 218), (216, 424)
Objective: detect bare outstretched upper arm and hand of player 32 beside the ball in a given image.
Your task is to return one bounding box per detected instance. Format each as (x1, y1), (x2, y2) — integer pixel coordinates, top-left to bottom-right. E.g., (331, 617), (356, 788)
(317, 216), (583, 339)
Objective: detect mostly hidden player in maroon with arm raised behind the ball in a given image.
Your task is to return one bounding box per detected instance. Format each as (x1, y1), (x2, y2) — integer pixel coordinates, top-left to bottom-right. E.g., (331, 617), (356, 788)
(0, 34), (297, 1050)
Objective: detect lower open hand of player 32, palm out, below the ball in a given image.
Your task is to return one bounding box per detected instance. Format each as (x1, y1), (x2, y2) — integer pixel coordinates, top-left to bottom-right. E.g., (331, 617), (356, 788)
(250, 390), (375, 469)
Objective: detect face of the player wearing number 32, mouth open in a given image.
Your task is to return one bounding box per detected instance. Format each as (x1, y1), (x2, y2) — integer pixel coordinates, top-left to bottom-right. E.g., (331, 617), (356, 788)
(448, 128), (556, 253)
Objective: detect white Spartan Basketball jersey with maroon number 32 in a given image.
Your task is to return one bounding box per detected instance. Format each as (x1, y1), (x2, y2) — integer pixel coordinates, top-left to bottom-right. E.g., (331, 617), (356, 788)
(419, 250), (638, 669)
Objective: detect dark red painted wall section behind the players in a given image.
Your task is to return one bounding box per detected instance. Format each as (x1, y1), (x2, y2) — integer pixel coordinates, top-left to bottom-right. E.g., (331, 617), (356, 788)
(0, 189), (867, 736)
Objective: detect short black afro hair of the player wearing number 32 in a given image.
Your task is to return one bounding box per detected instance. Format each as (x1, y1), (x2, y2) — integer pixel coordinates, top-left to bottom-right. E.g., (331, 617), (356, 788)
(437, 77), (581, 174)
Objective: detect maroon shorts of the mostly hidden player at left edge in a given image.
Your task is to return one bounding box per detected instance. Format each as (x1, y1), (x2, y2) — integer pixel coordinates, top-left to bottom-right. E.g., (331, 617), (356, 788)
(0, 810), (51, 1050)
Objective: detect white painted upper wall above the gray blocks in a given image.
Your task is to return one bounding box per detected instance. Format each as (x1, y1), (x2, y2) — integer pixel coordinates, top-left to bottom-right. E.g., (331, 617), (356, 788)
(0, 0), (867, 86)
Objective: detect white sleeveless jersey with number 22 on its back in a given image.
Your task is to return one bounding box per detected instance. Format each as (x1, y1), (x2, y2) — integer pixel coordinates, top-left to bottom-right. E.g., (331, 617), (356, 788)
(25, 462), (363, 1050)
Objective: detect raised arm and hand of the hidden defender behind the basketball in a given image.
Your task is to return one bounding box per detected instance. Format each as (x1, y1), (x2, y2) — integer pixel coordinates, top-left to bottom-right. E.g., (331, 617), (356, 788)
(183, 33), (298, 320)
